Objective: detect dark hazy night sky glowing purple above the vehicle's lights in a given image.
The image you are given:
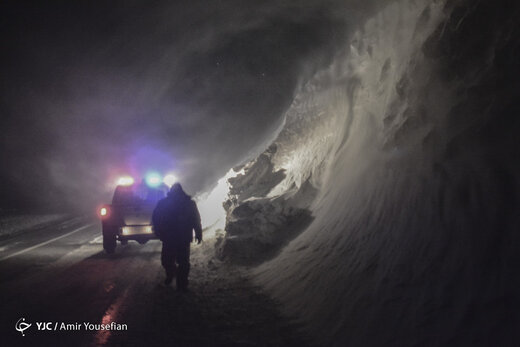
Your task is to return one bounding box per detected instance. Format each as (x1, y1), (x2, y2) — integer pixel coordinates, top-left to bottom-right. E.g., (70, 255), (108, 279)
(0, 1), (374, 209)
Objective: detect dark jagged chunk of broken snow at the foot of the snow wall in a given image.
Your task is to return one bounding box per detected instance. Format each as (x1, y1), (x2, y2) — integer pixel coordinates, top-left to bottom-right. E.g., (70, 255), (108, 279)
(217, 145), (316, 265)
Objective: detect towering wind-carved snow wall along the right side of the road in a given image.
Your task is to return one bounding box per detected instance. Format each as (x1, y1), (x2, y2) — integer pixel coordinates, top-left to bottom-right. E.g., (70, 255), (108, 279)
(219, 0), (520, 346)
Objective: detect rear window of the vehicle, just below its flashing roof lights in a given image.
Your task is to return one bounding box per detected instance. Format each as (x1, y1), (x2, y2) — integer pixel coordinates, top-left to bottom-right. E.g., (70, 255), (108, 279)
(112, 183), (167, 205)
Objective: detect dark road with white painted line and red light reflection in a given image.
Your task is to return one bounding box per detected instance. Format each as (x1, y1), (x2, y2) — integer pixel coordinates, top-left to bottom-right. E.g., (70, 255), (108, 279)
(0, 218), (309, 346)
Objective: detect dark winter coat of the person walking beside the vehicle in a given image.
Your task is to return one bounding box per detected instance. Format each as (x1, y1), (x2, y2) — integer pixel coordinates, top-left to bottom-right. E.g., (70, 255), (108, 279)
(152, 192), (202, 245)
